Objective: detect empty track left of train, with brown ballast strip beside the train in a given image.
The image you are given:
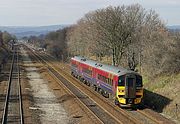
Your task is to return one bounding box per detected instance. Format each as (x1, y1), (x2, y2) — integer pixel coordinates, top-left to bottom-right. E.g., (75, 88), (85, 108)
(24, 46), (141, 124)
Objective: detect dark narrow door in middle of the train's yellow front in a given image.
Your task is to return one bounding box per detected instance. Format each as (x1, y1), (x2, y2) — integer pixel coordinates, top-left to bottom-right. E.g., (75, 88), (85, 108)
(125, 75), (136, 98)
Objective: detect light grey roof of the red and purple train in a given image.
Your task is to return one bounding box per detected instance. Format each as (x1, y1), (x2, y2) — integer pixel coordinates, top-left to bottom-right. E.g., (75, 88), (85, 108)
(72, 56), (139, 76)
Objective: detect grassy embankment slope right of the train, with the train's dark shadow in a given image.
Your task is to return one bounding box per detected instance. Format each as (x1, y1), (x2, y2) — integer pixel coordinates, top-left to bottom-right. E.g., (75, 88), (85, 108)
(144, 74), (180, 123)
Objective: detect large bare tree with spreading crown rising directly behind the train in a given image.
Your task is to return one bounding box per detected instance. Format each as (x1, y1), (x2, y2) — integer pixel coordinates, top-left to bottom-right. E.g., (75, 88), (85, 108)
(77, 4), (148, 65)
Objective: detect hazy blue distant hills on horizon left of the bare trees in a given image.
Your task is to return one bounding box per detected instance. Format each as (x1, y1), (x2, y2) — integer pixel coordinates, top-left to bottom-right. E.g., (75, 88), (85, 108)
(0, 25), (68, 38)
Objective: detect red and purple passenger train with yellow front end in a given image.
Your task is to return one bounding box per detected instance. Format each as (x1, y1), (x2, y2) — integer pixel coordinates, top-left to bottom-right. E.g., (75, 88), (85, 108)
(71, 56), (143, 107)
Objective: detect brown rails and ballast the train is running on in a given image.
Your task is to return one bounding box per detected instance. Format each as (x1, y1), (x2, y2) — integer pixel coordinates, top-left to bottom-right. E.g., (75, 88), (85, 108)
(43, 60), (159, 124)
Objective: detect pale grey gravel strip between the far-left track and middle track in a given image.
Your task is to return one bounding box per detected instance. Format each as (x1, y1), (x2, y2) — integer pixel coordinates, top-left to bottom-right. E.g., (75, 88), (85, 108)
(21, 49), (70, 124)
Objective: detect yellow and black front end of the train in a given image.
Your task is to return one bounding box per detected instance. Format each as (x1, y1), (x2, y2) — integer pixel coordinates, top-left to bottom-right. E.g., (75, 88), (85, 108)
(115, 74), (143, 107)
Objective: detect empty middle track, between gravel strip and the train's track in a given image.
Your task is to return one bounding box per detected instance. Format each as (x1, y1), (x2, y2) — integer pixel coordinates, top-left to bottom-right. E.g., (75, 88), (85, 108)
(26, 46), (122, 124)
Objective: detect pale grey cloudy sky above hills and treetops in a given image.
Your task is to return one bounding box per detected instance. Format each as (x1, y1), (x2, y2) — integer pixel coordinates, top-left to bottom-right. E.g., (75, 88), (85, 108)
(0, 0), (180, 26)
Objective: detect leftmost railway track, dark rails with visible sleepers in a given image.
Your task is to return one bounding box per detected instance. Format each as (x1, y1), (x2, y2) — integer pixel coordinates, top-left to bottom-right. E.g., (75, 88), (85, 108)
(1, 48), (24, 124)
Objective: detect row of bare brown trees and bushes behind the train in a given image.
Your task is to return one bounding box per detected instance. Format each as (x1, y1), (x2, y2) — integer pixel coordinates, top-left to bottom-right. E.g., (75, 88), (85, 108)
(29, 4), (180, 76)
